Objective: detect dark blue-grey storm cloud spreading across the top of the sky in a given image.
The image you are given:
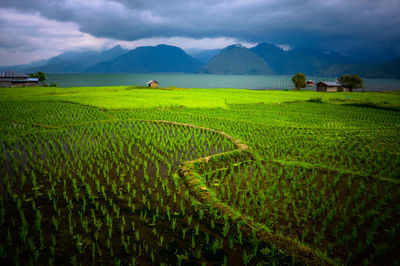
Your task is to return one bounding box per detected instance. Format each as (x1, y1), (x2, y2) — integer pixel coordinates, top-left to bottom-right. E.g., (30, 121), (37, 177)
(0, 0), (400, 57)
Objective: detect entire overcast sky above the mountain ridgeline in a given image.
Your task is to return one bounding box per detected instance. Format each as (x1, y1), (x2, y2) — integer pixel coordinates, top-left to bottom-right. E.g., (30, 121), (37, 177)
(0, 0), (400, 65)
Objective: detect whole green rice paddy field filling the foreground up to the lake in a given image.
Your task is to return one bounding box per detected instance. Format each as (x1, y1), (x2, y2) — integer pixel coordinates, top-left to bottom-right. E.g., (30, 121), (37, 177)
(0, 86), (400, 265)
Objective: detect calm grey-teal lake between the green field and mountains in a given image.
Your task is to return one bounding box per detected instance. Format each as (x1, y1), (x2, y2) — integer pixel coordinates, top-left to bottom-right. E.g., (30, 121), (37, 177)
(46, 73), (400, 90)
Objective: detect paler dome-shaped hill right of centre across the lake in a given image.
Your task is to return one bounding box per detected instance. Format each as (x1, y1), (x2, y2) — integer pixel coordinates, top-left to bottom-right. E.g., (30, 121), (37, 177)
(202, 45), (274, 75)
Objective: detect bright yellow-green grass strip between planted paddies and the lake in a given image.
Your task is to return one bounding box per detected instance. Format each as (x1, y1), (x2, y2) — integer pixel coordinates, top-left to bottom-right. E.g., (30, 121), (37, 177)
(0, 86), (400, 109)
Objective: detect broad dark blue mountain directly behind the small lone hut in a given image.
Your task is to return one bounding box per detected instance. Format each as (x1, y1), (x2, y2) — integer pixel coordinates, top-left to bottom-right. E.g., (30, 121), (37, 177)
(86, 44), (201, 73)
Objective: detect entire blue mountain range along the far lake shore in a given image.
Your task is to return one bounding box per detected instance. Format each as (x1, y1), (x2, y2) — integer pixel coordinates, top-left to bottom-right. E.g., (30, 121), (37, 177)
(0, 43), (400, 79)
